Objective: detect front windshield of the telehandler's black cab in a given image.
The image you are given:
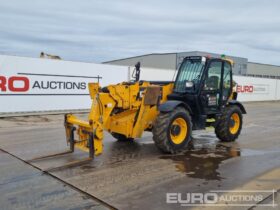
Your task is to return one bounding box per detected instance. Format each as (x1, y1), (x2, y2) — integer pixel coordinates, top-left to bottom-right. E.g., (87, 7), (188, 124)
(174, 58), (205, 92)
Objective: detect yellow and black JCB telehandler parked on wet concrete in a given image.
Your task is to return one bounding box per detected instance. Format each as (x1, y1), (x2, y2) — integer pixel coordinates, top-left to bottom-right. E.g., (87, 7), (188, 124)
(30, 56), (246, 167)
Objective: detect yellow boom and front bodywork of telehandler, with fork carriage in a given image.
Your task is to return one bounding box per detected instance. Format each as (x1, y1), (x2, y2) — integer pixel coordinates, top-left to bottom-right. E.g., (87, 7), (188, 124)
(65, 82), (173, 155)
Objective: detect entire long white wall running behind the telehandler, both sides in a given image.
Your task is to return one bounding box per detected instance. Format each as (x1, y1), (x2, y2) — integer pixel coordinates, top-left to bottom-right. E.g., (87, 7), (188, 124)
(0, 55), (280, 115)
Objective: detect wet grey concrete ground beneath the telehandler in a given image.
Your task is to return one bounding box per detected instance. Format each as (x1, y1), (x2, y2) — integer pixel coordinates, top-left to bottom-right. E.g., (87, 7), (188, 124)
(0, 102), (280, 209)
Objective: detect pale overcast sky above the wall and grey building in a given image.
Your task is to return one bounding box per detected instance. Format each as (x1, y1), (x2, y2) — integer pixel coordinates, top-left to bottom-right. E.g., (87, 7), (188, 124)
(0, 0), (280, 65)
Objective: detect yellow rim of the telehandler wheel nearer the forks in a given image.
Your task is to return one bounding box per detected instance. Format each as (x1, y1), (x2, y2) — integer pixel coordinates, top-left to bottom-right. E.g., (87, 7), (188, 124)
(170, 117), (188, 144)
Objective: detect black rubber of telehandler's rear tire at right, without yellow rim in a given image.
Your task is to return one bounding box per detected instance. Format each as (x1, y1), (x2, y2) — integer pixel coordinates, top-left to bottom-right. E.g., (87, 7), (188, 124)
(215, 105), (243, 142)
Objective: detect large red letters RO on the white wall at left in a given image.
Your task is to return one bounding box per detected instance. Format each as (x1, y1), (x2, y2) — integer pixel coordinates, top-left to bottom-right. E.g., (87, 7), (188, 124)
(0, 76), (30, 92)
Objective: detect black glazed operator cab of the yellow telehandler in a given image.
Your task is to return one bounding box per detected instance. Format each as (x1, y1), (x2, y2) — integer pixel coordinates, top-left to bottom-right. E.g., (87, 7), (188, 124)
(168, 56), (233, 128)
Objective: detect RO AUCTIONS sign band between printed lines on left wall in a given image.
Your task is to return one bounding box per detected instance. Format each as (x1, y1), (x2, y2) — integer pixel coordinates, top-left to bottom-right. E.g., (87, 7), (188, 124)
(0, 72), (95, 95)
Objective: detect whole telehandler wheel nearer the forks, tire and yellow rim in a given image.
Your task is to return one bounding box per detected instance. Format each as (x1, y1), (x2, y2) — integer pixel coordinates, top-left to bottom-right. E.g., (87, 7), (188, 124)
(153, 107), (192, 153)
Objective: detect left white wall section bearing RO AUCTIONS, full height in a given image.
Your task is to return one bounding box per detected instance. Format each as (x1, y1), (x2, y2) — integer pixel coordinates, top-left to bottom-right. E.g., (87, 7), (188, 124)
(0, 56), (128, 114)
